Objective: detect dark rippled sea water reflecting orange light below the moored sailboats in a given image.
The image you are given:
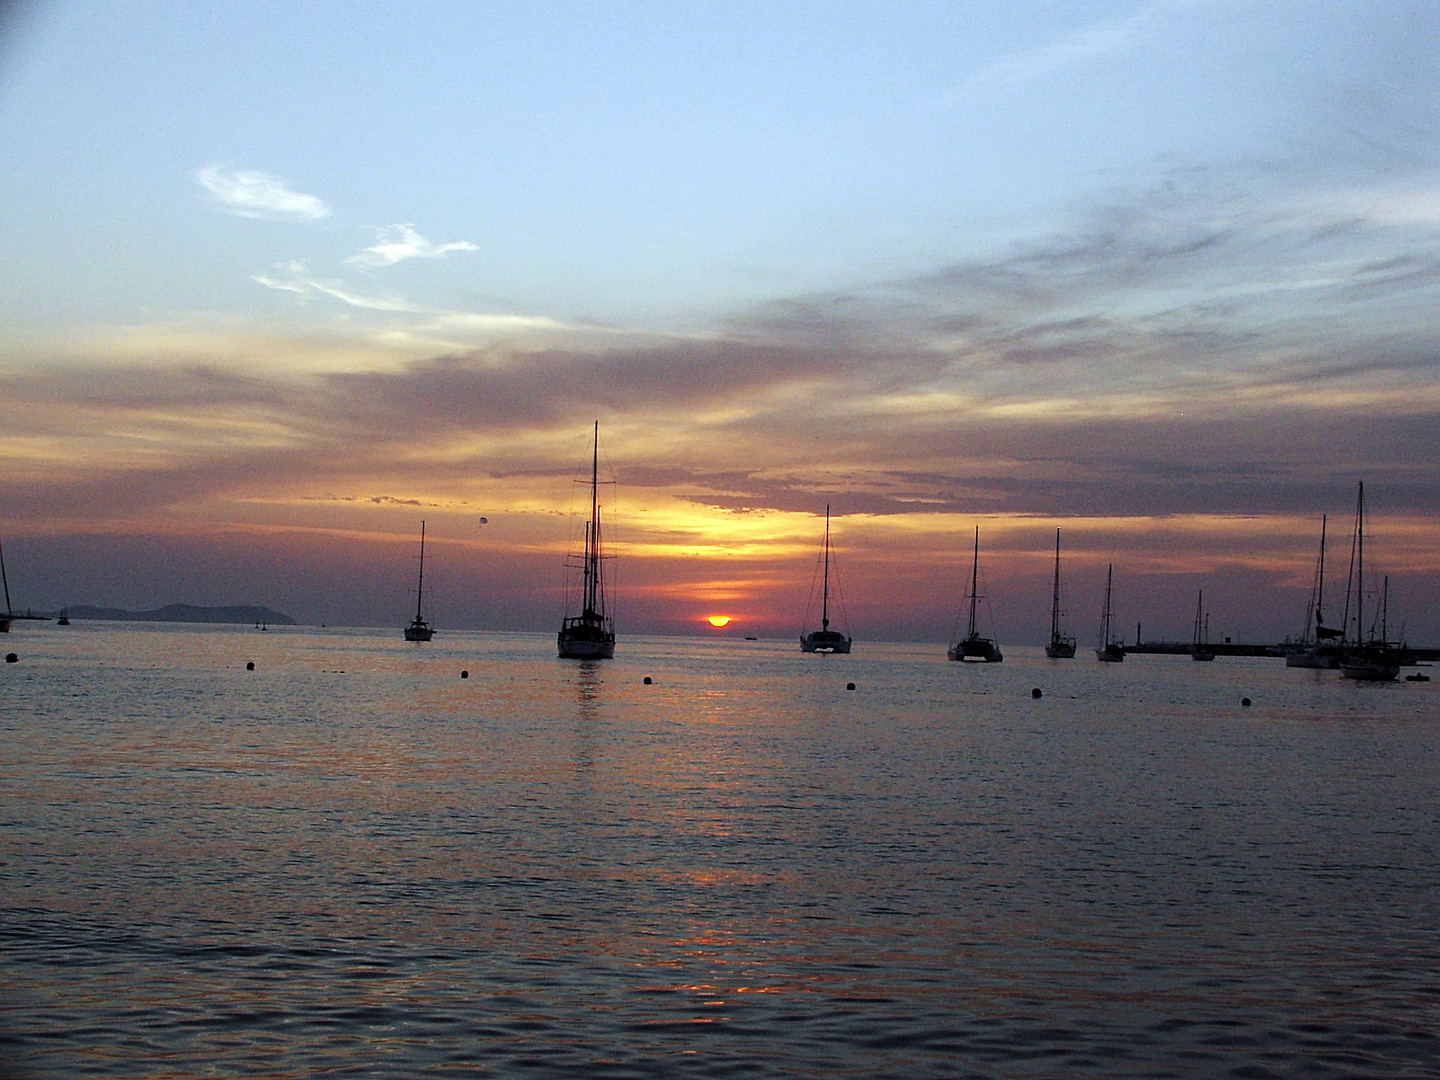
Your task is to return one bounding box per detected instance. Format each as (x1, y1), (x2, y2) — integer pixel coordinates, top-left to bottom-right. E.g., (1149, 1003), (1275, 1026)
(0, 624), (1440, 1077)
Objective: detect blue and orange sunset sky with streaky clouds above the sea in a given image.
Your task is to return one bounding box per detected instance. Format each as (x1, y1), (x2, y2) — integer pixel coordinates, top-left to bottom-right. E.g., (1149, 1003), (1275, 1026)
(0, 0), (1440, 648)
